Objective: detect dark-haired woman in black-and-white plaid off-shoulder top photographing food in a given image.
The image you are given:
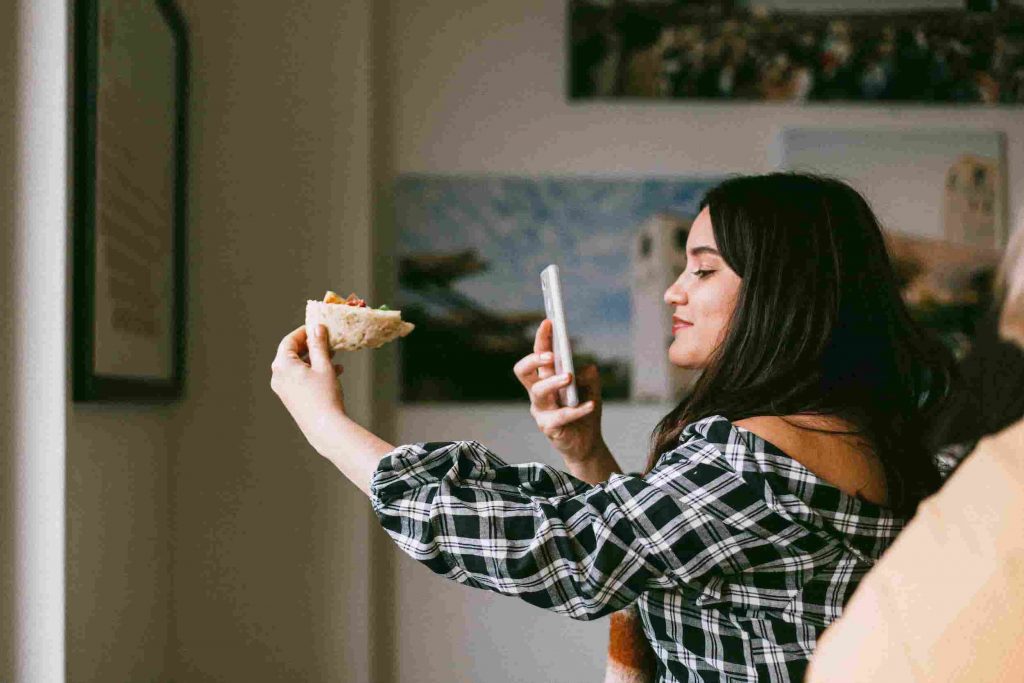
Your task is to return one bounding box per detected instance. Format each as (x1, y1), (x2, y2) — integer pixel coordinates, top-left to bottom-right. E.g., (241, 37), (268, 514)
(271, 174), (950, 681)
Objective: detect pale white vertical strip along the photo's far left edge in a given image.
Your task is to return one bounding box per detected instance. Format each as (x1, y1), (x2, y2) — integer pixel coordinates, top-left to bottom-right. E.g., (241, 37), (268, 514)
(0, 0), (68, 683)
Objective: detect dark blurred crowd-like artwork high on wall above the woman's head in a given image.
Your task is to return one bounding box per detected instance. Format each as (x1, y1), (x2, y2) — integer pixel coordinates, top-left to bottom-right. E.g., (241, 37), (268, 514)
(568, 0), (1024, 104)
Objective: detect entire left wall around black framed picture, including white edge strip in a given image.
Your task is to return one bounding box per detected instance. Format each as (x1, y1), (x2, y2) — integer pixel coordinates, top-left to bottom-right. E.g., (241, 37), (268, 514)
(7, 0), (374, 683)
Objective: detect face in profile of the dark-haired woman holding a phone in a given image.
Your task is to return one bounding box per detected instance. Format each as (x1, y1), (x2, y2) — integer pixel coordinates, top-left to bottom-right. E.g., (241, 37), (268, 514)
(665, 208), (741, 370)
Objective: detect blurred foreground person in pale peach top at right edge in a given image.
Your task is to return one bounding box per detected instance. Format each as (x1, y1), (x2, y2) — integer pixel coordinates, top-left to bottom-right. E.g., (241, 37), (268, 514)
(807, 220), (1024, 683)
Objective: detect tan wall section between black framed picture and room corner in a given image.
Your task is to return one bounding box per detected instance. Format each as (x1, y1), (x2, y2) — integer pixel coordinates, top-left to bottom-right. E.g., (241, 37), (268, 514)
(171, 0), (373, 683)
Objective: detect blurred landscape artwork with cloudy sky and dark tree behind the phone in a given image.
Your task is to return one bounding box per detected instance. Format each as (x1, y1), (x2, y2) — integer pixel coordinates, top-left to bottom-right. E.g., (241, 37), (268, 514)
(395, 175), (717, 401)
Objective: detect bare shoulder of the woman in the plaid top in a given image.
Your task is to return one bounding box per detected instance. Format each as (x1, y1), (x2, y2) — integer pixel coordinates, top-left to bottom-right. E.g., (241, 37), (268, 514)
(733, 415), (888, 505)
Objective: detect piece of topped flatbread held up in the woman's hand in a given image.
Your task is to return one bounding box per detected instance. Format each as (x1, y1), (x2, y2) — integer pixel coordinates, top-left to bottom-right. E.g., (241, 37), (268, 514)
(306, 290), (416, 351)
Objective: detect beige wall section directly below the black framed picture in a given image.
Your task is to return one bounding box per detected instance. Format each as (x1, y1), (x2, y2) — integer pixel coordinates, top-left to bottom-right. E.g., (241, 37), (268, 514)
(66, 403), (174, 683)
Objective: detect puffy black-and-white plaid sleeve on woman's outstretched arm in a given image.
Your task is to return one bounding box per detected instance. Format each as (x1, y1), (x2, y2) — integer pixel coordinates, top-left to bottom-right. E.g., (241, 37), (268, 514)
(371, 441), (842, 620)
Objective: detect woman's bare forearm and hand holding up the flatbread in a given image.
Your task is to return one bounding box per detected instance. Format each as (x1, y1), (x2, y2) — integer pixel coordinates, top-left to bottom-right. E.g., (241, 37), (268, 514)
(270, 326), (394, 496)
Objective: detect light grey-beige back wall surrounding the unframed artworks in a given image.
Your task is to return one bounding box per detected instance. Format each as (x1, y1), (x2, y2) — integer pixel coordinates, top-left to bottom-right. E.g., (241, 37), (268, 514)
(378, 0), (1024, 683)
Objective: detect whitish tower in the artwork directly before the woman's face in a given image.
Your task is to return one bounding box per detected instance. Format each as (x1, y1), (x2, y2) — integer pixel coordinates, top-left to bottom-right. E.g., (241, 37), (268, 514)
(630, 213), (696, 402)
